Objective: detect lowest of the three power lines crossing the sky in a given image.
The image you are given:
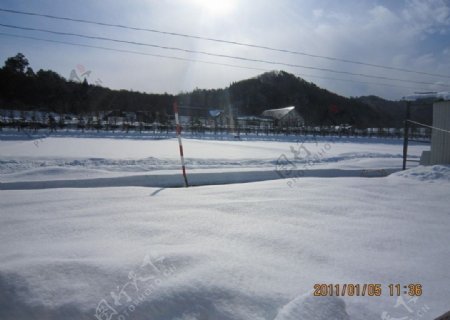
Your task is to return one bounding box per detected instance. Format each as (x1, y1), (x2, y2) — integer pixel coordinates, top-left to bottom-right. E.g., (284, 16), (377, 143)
(0, 32), (426, 89)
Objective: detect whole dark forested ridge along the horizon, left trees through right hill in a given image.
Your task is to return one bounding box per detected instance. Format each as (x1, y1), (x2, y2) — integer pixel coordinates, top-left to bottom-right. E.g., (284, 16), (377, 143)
(0, 54), (430, 127)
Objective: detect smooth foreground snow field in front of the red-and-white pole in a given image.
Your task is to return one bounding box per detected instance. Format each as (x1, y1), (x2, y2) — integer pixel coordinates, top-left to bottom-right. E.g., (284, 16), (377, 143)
(0, 175), (450, 319)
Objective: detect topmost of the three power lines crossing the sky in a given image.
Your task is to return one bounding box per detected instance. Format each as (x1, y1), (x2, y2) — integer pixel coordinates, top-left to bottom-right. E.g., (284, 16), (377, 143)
(0, 8), (450, 78)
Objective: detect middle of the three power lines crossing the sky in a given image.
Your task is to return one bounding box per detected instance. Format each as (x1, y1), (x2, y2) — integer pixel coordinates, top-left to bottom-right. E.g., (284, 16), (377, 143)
(0, 23), (450, 87)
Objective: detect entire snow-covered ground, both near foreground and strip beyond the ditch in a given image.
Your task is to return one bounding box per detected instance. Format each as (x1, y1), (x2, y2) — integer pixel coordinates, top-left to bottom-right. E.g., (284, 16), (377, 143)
(0, 131), (450, 320)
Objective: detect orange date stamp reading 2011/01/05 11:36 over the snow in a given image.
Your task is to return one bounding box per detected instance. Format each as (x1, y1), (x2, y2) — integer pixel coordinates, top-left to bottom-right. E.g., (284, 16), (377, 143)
(314, 283), (422, 297)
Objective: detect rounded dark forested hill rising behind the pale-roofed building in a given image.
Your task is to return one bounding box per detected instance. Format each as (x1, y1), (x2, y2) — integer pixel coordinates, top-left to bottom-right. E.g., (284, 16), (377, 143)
(229, 71), (388, 127)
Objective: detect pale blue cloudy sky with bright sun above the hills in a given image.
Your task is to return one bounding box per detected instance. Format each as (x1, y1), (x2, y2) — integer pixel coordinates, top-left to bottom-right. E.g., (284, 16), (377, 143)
(0, 0), (450, 99)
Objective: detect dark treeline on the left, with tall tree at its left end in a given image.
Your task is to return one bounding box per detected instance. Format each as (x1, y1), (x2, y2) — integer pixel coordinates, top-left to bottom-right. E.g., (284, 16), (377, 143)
(0, 53), (174, 119)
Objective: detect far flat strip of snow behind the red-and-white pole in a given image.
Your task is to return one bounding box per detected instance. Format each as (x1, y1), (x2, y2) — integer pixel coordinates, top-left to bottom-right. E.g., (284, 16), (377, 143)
(0, 132), (429, 186)
